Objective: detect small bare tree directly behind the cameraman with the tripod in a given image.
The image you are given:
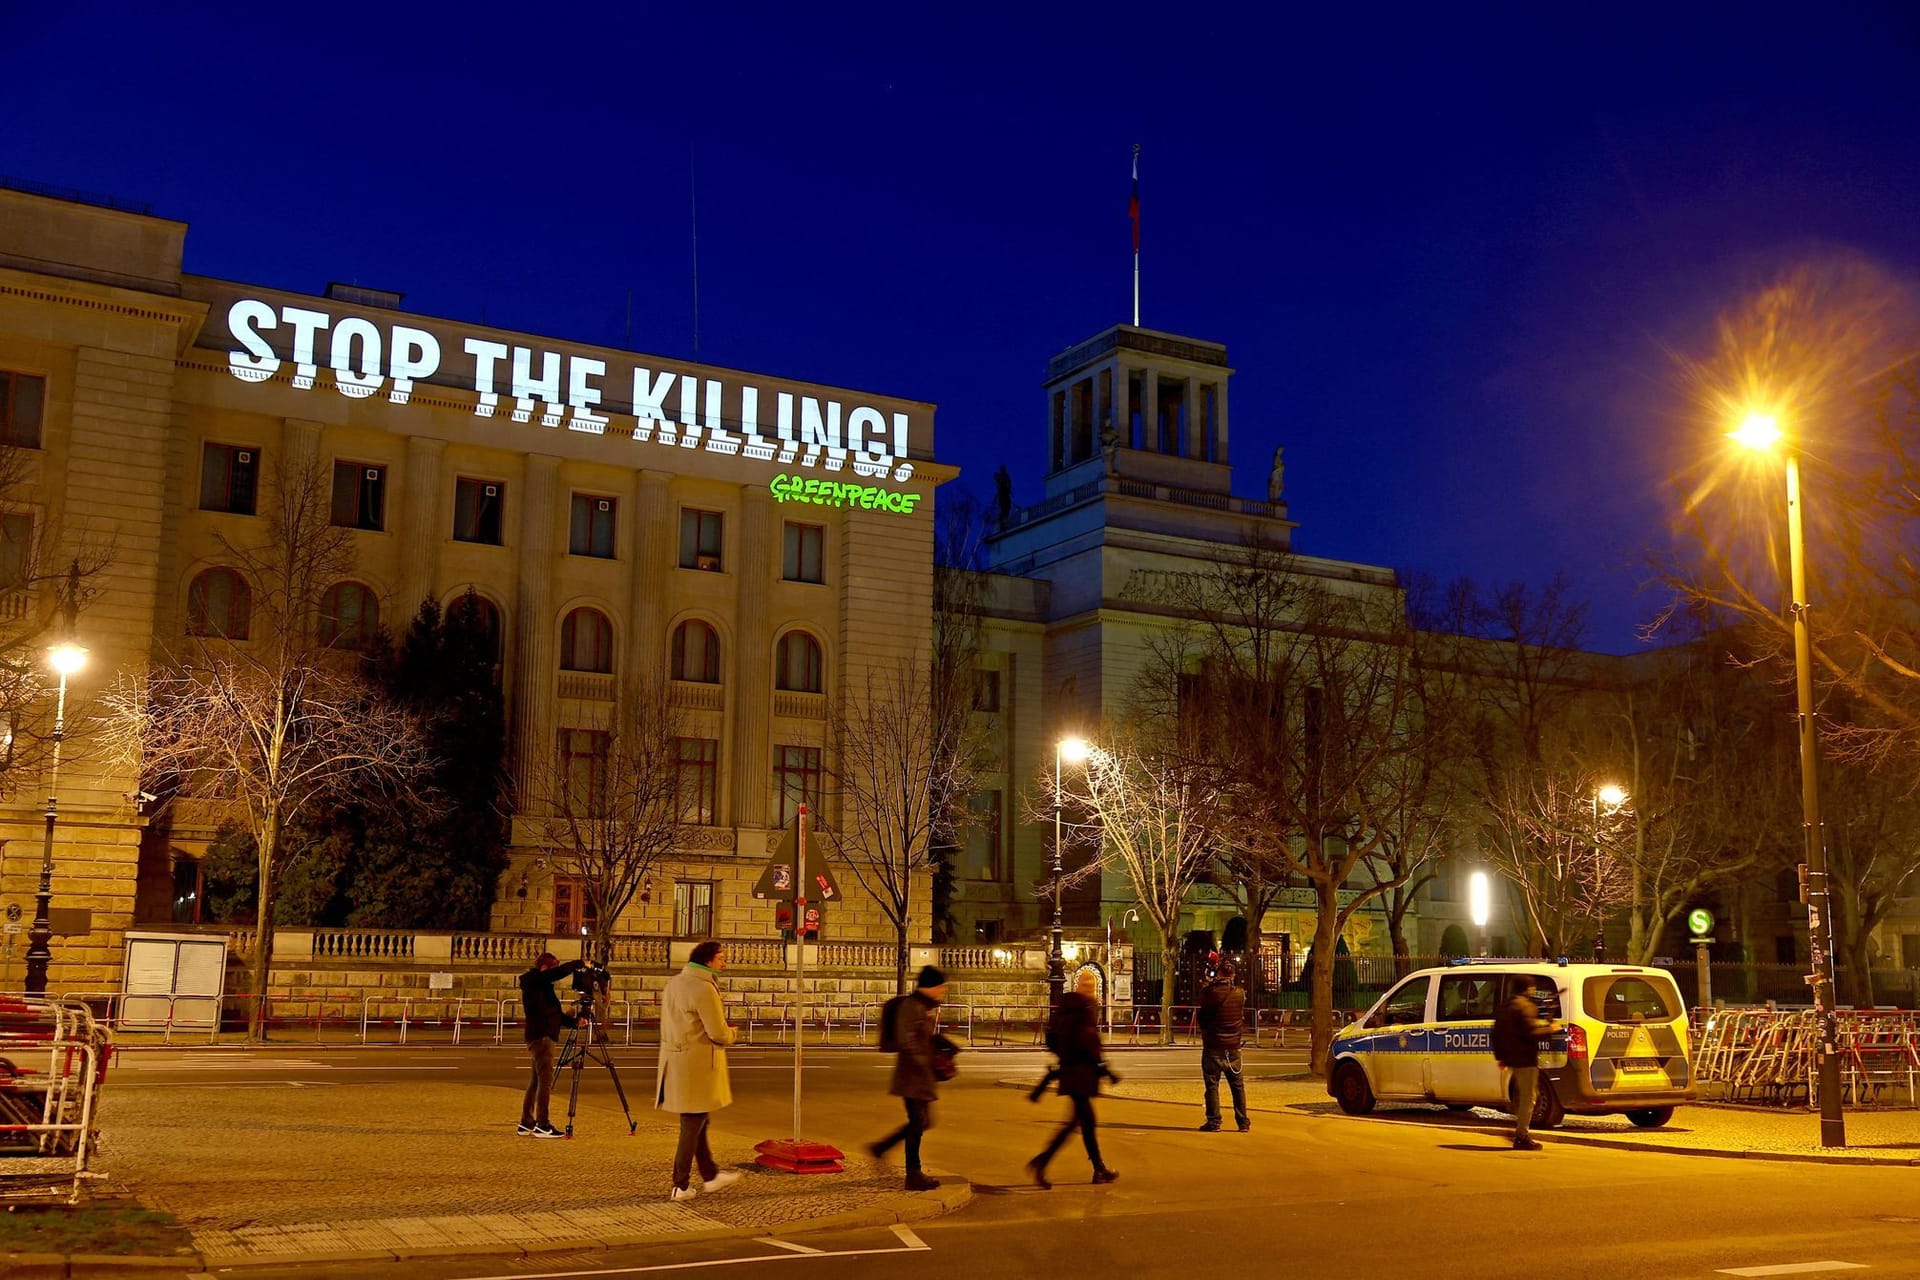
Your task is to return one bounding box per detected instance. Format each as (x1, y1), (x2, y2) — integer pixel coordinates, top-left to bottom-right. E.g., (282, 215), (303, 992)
(528, 679), (699, 960)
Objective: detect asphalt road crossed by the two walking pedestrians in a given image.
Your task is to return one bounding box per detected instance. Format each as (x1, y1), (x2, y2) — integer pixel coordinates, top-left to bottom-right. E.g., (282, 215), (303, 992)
(111, 1044), (1920, 1280)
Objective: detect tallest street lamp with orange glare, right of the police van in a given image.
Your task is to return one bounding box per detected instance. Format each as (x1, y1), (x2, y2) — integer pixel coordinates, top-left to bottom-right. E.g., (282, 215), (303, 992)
(1728, 411), (1847, 1148)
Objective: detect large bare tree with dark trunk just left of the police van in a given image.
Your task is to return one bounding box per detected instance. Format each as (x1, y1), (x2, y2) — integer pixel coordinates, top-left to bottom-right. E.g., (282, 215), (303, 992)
(1158, 564), (1448, 1071)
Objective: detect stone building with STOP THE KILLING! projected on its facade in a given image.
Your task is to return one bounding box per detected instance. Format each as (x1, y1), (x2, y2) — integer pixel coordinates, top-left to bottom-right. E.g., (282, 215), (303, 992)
(0, 190), (952, 990)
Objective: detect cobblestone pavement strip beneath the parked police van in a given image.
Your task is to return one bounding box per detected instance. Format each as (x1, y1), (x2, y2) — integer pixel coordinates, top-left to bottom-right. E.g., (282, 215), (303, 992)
(1090, 1074), (1920, 1163)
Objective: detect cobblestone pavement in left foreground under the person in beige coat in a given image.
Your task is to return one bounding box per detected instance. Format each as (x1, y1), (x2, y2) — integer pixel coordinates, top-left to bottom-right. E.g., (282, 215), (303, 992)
(94, 1084), (970, 1267)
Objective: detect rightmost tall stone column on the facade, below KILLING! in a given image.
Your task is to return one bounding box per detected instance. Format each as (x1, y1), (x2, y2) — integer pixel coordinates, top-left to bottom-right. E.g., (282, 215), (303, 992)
(728, 486), (778, 827)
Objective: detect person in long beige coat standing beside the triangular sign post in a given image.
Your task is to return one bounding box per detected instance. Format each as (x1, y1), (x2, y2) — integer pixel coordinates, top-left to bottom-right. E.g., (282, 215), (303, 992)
(653, 940), (741, 1199)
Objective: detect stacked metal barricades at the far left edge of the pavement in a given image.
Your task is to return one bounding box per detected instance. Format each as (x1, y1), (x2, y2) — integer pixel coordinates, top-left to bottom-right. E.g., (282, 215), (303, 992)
(0, 996), (113, 1203)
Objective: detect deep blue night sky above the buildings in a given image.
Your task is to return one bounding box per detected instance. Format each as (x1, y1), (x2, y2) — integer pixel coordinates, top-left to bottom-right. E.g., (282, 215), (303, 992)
(15, 2), (1920, 651)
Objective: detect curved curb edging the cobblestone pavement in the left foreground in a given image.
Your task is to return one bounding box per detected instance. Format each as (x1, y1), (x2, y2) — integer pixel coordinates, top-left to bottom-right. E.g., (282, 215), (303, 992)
(43, 1169), (973, 1280)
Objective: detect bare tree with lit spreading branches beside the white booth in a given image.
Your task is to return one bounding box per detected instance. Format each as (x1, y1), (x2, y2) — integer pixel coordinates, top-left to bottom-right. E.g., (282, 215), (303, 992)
(109, 457), (428, 1038)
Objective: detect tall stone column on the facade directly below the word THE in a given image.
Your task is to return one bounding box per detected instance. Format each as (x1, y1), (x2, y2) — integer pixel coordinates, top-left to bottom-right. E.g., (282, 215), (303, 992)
(509, 453), (561, 812)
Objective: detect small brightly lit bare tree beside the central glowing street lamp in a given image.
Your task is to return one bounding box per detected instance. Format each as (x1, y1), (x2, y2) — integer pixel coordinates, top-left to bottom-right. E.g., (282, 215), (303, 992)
(1041, 731), (1219, 1044)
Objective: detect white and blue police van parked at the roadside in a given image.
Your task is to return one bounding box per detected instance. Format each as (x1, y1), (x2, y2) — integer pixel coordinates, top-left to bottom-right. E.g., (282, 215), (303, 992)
(1327, 960), (1693, 1128)
